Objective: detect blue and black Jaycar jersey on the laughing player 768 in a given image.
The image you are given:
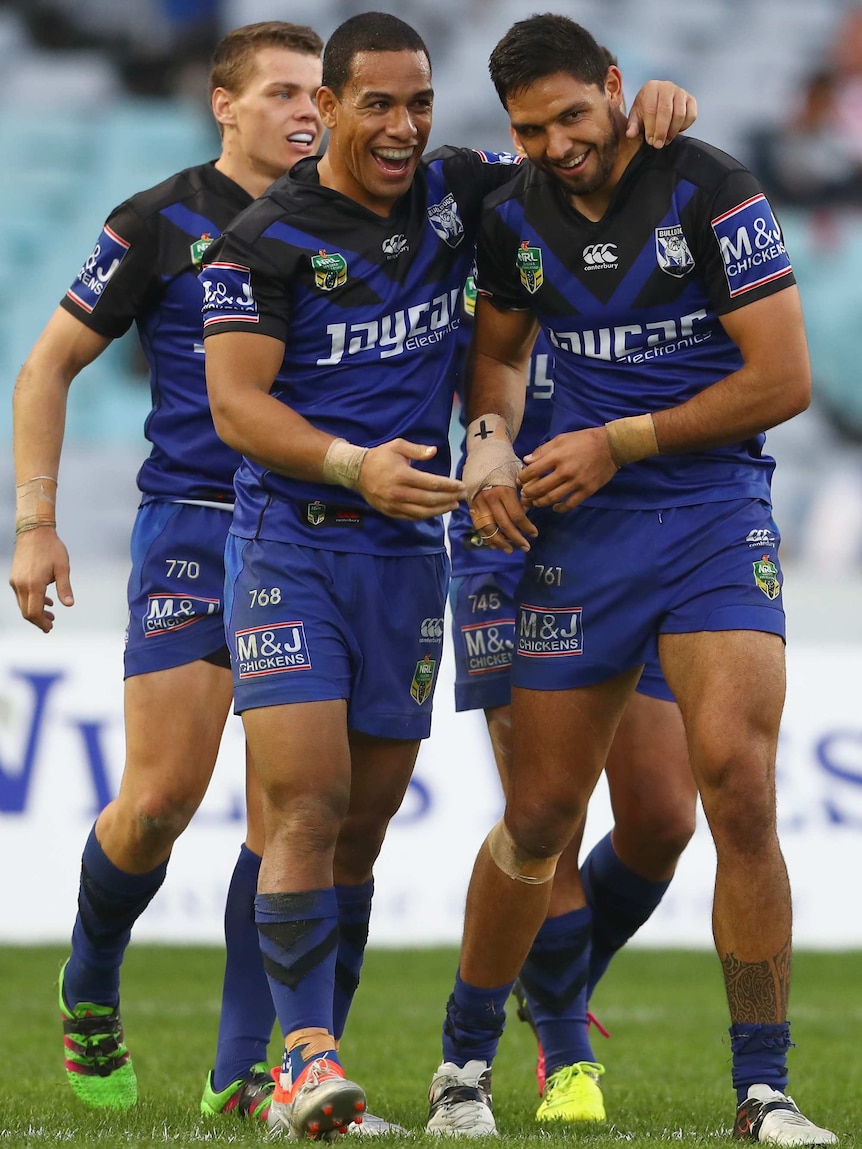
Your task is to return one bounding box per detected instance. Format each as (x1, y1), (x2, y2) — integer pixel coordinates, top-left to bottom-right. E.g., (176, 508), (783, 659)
(200, 147), (517, 555)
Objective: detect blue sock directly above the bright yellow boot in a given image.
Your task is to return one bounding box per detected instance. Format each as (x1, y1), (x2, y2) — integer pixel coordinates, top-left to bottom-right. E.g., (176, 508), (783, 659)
(521, 905), (595, 1077)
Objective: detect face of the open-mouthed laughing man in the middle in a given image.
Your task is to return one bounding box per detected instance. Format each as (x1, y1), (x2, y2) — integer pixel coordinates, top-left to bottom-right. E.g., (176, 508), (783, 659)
(318, 51), (433, 216)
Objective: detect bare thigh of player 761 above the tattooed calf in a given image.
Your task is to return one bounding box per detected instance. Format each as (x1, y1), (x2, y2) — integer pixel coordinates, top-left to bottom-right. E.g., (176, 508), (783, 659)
(659, 631), (786, 815)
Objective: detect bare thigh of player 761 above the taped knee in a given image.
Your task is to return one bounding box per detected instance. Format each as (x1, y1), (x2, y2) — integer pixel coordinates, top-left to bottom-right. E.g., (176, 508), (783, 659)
(506, 666), (640, 848)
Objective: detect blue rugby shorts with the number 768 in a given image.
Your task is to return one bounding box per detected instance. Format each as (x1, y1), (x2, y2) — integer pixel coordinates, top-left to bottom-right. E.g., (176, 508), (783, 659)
(225, 534), (449, 740)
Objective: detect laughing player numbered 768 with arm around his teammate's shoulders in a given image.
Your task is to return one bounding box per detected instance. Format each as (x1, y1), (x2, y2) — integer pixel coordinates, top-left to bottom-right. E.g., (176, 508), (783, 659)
(201, 13), (703, 1139)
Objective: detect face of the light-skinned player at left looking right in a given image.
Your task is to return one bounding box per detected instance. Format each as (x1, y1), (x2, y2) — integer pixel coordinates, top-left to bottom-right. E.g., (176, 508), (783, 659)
(213, 47), (323, 195)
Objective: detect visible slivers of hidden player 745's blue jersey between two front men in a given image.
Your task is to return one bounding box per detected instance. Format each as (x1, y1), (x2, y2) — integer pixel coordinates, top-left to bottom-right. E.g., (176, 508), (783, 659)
(448, 277), (554, 578)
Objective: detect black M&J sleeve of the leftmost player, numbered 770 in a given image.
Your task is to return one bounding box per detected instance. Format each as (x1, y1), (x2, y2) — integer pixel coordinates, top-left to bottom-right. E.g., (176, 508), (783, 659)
(60, 201), (160, 339)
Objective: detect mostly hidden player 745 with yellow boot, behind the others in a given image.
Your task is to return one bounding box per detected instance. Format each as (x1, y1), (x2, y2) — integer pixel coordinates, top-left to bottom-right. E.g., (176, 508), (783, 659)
(448, 287), (696, 1121)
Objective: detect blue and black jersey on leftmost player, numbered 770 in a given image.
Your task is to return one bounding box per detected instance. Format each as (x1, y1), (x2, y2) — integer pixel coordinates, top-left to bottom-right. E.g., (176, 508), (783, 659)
(61, 163), (252, 502)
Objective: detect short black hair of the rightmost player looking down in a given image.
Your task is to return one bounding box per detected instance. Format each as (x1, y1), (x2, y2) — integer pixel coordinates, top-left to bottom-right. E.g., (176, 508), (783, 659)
(488, 11), (614, 107)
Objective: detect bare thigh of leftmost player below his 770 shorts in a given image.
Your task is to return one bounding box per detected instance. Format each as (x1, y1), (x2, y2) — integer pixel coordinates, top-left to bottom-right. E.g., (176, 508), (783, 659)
(121, 658), (231, 805)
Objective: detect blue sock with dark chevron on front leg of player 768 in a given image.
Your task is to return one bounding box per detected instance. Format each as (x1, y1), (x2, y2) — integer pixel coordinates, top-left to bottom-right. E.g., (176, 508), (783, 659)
(254, 886), (338, 1074)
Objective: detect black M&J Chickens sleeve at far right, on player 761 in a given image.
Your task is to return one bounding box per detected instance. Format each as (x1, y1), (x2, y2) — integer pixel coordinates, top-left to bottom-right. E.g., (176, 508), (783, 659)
(696, 168), (795, 315)
